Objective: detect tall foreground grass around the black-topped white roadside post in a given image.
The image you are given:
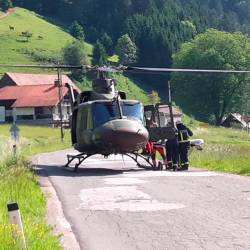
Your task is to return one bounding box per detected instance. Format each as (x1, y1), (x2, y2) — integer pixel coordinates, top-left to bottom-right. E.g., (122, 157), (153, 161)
(0, 158), (61, 250)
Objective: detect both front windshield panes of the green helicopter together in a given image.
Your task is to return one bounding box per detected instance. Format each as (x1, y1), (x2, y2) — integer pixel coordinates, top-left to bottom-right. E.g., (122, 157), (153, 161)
(93, 102), (143, 127)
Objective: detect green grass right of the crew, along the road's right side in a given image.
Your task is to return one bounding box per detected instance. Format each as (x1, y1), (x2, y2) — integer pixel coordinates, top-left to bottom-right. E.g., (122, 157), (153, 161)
(190, 127), (250, 176)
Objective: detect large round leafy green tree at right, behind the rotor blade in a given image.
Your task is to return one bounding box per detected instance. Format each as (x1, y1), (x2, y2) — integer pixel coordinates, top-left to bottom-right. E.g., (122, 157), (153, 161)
(172, 29), (250, 125)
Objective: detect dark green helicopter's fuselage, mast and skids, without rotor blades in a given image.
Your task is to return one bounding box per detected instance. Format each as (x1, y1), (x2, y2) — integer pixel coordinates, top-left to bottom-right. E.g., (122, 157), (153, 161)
(68, 71), (149, 171)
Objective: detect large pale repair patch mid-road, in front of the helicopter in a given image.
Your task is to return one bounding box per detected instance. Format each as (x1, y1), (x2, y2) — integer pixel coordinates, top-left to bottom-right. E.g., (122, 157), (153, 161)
(80, 186), (186, 212)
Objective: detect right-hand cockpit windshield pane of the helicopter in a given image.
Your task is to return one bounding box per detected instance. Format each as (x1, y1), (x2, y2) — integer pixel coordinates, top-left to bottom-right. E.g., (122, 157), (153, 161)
(121, 103), (143, 122)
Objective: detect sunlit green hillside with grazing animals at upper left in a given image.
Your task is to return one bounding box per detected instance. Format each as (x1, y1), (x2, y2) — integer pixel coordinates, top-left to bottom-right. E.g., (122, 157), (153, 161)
(0, 8), (92, 74)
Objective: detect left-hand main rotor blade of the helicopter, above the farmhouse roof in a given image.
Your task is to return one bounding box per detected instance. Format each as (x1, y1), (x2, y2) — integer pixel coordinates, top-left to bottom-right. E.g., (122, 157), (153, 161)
(0, 64), (84, 69)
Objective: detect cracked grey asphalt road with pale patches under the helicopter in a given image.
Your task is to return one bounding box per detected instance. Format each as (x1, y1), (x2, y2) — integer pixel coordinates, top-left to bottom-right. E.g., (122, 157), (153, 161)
(35, 151), (250, 250)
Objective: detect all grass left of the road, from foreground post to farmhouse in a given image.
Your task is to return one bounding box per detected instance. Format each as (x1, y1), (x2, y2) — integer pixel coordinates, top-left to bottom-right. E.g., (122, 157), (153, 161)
(0, 125), (70, 250)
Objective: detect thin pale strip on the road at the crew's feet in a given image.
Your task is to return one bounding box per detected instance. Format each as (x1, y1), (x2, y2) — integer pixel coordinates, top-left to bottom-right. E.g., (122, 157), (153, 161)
(123, 171), (221, 178)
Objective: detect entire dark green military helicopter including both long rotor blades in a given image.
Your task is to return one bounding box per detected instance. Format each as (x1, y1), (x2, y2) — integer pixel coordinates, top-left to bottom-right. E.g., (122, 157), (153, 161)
(0, 64), (250, 171)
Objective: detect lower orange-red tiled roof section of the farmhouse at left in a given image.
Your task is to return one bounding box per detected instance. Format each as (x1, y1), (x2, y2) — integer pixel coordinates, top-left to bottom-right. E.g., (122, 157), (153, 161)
(0, 84), (68, 108)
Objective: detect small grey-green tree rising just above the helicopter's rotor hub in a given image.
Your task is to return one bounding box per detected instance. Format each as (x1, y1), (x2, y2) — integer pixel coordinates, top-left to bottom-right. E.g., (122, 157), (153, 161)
(115, 34), (137, 65)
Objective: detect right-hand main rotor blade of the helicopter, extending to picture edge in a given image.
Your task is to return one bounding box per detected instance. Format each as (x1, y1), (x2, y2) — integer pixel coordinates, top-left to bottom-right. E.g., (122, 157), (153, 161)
(124, 67), (250, 73)
